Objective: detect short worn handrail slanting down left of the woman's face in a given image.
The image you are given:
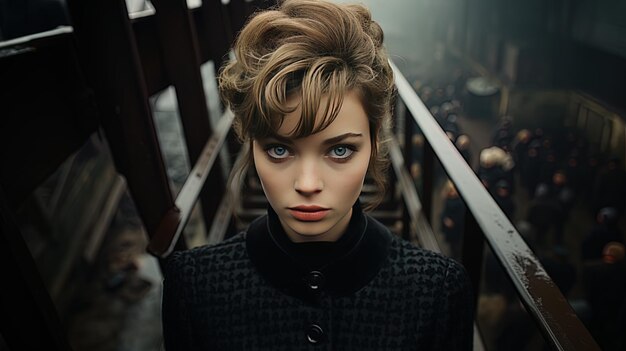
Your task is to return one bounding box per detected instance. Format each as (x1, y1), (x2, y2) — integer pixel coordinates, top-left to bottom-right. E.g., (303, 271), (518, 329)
(148, 110), (234, 258)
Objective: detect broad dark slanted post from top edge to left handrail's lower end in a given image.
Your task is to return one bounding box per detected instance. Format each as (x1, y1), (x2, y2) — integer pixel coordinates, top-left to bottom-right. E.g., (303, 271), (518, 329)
(68, 0), (177, 242)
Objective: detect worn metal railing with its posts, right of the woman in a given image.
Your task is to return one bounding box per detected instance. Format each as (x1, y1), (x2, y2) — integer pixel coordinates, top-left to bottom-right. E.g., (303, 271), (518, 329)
(392, 63), (599, 350)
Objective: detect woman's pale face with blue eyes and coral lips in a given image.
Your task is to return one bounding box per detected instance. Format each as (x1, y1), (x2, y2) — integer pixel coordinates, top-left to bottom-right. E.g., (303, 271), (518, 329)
(253, 92), (372, 242)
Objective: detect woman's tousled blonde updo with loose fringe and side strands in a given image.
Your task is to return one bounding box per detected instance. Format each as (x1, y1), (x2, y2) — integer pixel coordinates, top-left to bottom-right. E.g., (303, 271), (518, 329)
(219, 0), (394, 209)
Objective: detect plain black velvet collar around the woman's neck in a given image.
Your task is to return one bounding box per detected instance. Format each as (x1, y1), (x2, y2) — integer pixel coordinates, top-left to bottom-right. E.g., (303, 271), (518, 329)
(246, 201), (390, 302)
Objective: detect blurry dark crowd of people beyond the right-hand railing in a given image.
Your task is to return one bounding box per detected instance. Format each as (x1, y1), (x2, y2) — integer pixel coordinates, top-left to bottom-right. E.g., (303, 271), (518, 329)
(412, 76), (626, 350)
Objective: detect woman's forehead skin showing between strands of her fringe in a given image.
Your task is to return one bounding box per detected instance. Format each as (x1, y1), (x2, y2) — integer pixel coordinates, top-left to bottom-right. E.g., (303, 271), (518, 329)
(275, 92), (369, 139)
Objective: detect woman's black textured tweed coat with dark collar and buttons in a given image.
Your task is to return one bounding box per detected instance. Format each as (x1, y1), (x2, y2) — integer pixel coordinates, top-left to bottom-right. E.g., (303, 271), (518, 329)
(162, 203), (473, 351)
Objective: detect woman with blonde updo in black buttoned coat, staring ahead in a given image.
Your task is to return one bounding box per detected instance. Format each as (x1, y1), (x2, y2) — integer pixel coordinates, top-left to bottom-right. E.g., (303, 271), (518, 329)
(163, 0), (473, 350)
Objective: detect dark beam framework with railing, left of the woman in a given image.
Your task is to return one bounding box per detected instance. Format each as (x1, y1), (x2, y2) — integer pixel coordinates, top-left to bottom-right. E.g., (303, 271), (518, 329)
(0, 0), (253, 350)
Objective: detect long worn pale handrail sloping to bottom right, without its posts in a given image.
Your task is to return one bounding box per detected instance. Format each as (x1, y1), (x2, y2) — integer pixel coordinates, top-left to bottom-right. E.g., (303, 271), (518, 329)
(390, 62), (599, 350)
